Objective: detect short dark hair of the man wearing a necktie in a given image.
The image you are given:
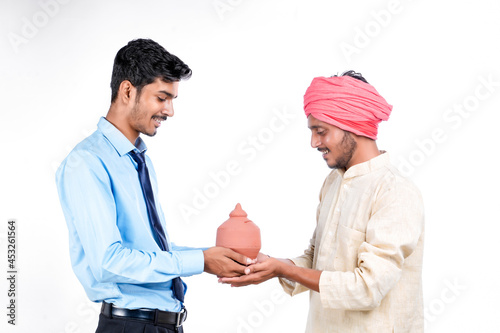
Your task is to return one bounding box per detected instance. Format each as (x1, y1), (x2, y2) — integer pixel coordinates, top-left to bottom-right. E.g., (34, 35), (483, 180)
(111, 39), (192, 103)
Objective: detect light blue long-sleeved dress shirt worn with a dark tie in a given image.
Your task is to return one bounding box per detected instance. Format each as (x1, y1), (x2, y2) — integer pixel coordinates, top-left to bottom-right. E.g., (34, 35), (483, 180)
(56, 118), (204, 311)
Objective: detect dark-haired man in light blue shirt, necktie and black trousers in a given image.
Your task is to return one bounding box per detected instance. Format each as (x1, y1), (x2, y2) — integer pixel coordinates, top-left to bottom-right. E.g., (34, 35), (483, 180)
(56, 39), (251, 333)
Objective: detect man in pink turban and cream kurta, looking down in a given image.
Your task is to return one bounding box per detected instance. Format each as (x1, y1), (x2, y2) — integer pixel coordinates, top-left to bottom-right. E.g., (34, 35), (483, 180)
(220, 71), (424, 333)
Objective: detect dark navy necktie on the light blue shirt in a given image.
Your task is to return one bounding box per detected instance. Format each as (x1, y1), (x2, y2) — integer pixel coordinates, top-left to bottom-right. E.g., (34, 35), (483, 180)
(131, 152), (184, 302)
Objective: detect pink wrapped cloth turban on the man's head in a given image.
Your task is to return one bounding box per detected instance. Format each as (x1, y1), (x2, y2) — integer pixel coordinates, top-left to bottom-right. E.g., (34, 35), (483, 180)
(304, 76), (392, 140)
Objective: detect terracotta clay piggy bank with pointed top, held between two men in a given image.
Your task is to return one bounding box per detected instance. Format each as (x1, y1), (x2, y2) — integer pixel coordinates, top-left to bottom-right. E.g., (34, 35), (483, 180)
(215, 204), (261, 259)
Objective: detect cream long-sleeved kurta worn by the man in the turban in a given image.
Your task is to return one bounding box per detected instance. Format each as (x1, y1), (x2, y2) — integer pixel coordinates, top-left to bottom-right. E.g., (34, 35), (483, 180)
(280, 153), (424, 333)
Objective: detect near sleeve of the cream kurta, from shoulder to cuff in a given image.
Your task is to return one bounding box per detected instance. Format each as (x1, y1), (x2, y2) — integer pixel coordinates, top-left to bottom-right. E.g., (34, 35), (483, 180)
(319, 176), (424, 310)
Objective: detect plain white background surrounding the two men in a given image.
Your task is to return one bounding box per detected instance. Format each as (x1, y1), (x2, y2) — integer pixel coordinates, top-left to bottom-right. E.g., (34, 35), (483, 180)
(0, 0), (500, 333)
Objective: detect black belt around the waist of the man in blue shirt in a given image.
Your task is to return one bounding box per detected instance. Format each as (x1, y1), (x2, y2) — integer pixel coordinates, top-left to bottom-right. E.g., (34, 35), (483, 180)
(101, 302), (187, 327)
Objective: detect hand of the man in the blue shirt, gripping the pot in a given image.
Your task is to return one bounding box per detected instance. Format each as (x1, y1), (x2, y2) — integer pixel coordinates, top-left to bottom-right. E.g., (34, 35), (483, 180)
(203, 247), (255, 277)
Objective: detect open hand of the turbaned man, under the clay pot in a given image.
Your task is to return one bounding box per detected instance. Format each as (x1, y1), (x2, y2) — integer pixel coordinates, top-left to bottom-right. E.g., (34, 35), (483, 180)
(219, 253), (289, 287)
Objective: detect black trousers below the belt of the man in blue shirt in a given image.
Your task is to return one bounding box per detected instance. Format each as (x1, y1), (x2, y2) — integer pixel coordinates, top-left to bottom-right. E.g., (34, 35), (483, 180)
(95, 313), (184, 333)
